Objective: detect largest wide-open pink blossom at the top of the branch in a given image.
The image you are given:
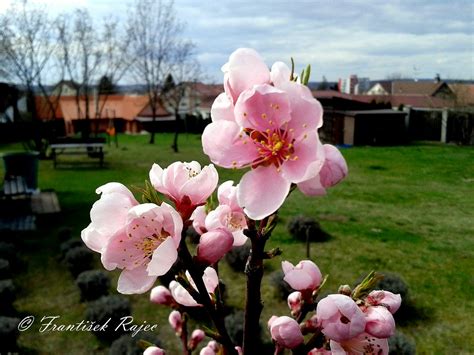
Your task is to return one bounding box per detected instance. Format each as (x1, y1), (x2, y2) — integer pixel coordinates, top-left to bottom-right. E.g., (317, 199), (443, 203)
(202, 50), (324, 220)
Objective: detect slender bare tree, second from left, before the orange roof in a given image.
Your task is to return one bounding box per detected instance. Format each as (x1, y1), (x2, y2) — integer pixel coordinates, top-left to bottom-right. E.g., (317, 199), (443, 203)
(57, 9), (102, 138)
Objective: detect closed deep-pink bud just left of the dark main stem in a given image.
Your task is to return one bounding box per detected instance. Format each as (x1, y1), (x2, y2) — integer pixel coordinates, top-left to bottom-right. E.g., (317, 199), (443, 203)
(197, 228), (234, 264)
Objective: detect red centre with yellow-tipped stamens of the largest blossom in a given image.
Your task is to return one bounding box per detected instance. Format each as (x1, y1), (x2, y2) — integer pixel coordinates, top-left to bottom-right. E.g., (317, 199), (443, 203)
(245, 129), (298, 171)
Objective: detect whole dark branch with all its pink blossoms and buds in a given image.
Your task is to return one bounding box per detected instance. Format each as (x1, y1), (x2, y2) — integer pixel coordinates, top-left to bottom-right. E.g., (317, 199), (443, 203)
(81, 48), (401, 355)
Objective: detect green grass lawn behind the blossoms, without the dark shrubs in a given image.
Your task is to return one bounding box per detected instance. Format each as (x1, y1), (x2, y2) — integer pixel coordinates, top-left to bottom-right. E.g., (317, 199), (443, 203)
(0, 134), (474, 354)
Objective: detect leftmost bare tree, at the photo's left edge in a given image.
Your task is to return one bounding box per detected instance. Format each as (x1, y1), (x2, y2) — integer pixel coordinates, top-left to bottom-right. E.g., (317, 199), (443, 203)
(0, 0), (54, 152)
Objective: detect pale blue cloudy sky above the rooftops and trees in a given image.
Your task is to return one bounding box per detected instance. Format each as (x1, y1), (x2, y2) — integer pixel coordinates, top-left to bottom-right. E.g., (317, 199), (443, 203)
(0, 0), (474, 82)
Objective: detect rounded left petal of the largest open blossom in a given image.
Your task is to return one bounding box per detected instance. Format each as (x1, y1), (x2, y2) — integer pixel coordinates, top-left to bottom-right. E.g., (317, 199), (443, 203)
(202, 121), (258, 168)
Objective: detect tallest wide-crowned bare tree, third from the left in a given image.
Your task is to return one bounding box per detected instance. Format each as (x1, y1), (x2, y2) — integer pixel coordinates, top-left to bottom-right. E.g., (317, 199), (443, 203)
(128, 0), (193, 144)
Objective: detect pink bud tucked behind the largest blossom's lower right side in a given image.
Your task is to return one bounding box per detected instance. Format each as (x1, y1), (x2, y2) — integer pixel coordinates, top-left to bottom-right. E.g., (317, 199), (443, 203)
(298, 144), (348, 196)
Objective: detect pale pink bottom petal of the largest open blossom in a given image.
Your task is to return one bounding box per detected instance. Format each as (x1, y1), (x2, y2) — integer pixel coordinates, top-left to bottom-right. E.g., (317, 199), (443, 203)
(237, 166), (291, 220)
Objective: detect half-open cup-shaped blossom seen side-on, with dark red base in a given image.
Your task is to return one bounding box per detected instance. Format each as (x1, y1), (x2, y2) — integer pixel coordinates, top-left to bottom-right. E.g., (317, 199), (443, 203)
(150, 161), (219, 219)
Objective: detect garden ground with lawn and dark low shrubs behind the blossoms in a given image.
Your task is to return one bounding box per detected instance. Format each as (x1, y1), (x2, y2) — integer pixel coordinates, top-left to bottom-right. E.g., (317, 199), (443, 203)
(0, 133), (474, 354)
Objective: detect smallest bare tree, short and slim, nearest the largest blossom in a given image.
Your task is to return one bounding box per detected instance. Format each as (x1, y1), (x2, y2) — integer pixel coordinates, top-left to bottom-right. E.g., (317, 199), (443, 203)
(162, 42), (201, 153)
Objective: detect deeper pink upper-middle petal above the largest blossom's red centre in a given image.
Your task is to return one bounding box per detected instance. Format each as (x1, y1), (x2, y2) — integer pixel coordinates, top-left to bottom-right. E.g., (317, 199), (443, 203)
(234, 84), (291, 132)
